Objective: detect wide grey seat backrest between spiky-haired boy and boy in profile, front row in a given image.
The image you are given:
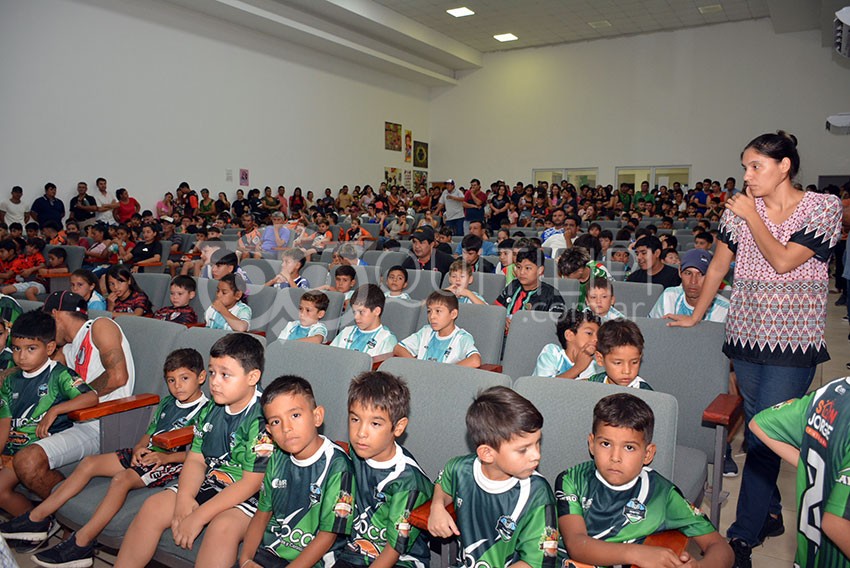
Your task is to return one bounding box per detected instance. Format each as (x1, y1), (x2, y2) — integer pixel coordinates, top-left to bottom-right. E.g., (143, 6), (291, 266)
(381, 357), (510, 479)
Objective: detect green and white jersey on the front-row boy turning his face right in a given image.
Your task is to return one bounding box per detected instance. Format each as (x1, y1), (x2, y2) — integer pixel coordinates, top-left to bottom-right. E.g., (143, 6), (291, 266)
(436, 455), (558, 568)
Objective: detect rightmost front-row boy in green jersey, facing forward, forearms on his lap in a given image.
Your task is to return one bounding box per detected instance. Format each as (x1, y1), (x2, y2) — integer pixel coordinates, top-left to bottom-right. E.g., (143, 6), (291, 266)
(555, 393), (734, 568)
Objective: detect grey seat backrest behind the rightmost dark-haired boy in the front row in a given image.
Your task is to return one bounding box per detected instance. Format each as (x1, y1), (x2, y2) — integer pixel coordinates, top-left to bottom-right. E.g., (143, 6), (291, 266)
(514, 377), (679, 483)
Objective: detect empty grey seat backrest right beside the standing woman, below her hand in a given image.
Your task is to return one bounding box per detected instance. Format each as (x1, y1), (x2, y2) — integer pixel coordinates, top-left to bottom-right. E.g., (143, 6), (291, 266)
(635, 318), (729, 461)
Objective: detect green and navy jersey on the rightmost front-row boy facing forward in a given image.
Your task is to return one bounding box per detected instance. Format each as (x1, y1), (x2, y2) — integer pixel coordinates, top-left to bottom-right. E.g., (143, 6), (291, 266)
(555, 461), (714, 543)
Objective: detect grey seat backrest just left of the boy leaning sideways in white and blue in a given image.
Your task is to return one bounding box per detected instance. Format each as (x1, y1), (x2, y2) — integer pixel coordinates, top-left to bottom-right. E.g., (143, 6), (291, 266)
(502, 311), (561, 379)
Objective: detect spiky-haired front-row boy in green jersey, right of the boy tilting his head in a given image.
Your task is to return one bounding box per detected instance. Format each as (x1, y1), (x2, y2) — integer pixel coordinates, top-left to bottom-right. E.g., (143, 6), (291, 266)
(334, 371), (434, 568)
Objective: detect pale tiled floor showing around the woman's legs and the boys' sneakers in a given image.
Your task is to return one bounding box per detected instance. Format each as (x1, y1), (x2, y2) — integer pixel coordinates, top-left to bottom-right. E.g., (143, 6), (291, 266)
(6, 284), (850, 568)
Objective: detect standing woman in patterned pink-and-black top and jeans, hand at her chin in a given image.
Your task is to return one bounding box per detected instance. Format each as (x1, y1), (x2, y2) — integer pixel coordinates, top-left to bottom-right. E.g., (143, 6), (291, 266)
(668, 131), (841, 568)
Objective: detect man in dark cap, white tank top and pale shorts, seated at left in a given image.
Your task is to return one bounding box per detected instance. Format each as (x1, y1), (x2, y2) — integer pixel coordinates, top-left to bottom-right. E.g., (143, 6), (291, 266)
(15, 291), (135, 498)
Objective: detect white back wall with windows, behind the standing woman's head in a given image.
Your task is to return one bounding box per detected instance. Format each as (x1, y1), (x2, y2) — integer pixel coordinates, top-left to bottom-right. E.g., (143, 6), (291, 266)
(430, 20), (850, 189)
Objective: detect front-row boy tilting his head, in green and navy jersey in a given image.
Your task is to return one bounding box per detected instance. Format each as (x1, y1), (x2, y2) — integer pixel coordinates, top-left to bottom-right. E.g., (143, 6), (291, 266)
(239, 375), (354, 568)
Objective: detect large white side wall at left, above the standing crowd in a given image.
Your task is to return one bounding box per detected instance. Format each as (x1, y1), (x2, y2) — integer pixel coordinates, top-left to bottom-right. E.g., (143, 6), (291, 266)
(0, 0), (430, 208)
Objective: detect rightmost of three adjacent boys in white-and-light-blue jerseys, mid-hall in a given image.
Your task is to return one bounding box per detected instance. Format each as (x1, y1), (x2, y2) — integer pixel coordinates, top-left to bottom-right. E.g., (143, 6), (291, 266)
(393, 290), (481, 369)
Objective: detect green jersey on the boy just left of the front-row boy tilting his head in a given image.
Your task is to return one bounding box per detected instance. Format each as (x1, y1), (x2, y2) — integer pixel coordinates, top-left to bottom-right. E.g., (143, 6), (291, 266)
(192, 392), (274, 485)
